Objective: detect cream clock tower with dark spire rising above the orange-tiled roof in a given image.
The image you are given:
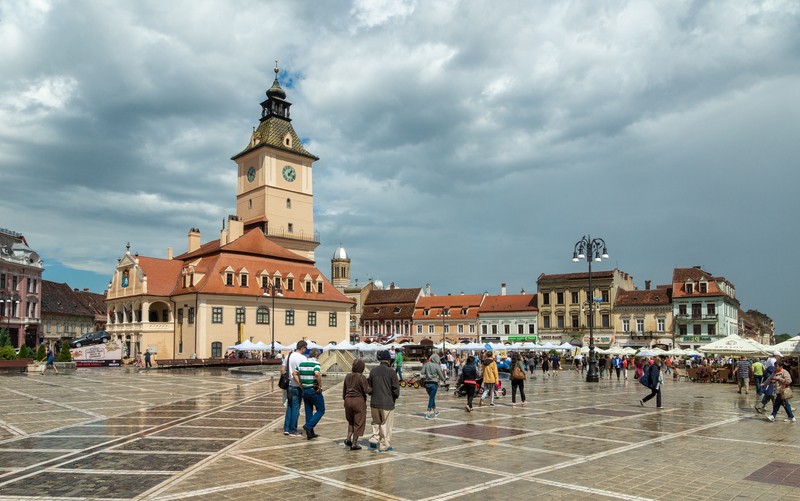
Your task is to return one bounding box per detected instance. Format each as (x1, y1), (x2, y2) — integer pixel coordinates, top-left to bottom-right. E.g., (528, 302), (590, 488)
(231, 64), (319, 259)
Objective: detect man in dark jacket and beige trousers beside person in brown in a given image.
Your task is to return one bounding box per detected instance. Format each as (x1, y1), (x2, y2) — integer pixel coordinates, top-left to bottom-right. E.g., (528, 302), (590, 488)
(369, 351), (400, 452)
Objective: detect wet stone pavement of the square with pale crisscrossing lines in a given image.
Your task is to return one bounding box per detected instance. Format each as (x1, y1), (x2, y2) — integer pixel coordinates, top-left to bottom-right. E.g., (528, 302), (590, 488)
(0, 369), (800, 501)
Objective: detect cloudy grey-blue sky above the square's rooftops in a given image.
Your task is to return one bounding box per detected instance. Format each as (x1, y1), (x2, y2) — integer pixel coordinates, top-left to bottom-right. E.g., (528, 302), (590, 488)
(0, 0), (800, 334)
